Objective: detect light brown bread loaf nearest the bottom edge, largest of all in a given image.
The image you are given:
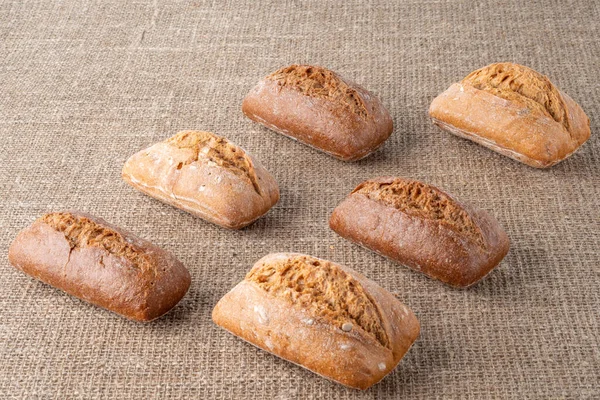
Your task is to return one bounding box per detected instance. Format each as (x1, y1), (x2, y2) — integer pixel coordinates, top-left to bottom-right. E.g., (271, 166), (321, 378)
(213, 253), (420, 390)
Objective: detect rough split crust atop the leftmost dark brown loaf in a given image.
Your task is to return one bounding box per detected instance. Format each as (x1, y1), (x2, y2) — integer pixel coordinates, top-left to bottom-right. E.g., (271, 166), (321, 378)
(40, 212), (156, 274)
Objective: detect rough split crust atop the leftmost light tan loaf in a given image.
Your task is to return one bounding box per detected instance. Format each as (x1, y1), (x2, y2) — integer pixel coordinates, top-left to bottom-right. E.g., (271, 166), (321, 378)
(165, 131), (261, 195)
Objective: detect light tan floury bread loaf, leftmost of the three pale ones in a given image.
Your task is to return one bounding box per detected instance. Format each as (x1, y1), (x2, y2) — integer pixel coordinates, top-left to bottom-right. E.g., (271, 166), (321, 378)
(122, 131), (279, 229)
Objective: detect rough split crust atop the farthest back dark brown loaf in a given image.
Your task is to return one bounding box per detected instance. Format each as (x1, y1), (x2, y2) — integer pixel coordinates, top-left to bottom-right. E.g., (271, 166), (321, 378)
(267, 64), (369, 119)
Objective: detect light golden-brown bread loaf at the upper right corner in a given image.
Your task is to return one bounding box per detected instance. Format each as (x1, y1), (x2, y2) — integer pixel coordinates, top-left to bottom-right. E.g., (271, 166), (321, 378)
(429, 63), (590, 168)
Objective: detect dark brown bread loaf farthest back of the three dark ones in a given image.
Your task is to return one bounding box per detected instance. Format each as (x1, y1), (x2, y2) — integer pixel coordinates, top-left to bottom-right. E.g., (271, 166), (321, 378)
(242, 65), (393, 161)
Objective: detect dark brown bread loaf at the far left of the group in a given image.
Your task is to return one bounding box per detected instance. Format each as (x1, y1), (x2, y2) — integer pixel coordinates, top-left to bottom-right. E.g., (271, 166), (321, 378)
(8, 212), (190, 321)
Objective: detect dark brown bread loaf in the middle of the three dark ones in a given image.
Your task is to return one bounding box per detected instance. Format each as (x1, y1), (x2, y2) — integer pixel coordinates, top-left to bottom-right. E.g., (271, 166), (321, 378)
(329, 177), (509, 287)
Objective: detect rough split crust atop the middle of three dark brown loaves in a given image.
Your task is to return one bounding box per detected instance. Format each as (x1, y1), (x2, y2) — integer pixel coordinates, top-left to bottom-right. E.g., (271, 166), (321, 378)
(352, 178), (483, 247)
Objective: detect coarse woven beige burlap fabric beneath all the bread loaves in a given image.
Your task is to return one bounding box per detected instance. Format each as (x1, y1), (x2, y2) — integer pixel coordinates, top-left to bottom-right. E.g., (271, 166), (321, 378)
(0, 0), (600, 399)
